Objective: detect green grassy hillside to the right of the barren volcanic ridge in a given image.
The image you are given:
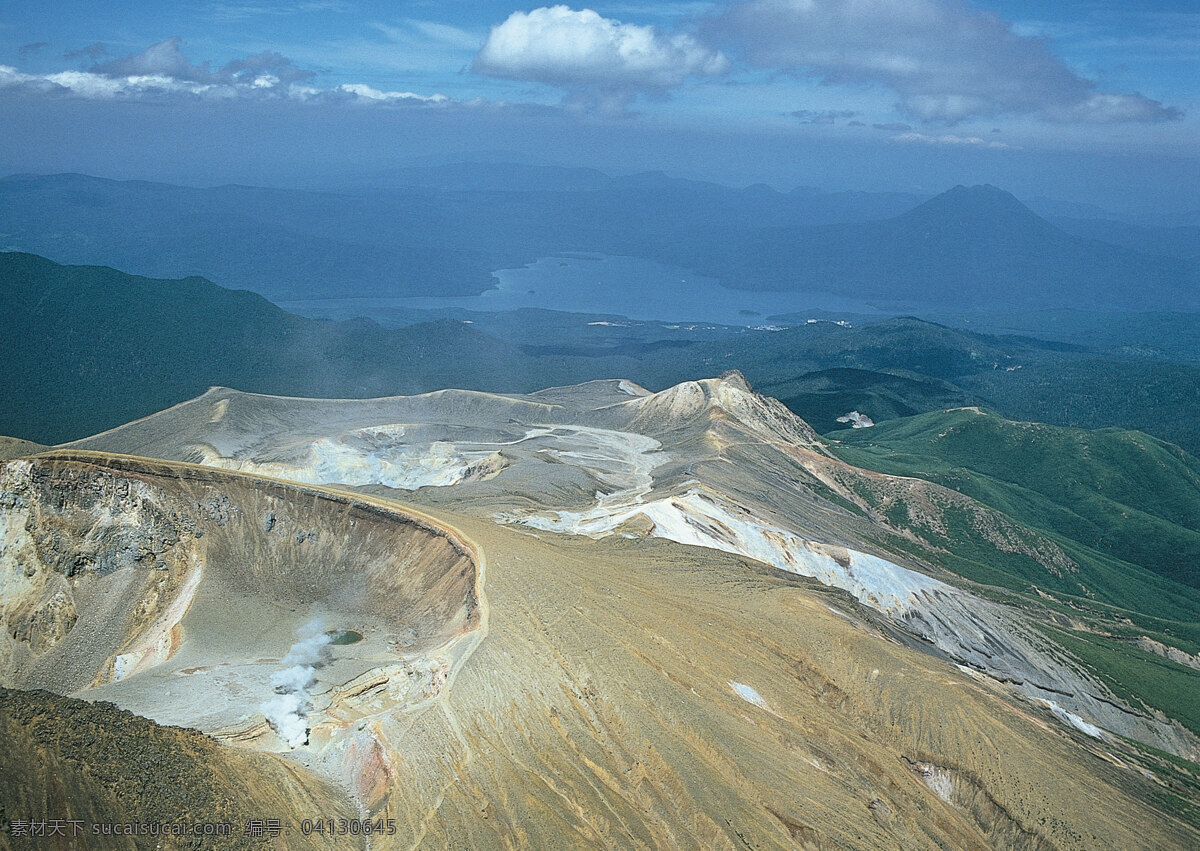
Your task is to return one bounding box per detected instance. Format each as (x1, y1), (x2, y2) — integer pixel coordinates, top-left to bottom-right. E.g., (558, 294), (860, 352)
(834, 408), (1200, 587)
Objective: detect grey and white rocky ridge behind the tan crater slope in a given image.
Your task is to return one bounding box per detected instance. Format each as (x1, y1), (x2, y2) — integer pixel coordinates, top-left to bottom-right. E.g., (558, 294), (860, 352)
(65, 373), (1200, 759)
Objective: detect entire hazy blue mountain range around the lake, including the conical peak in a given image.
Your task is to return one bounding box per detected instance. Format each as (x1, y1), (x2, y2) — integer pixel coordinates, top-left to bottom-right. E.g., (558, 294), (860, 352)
(7, 164), (1200, 319)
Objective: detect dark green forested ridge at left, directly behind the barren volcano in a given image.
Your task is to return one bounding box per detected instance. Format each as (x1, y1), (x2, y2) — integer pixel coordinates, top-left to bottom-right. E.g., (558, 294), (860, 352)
(0, 253), (539, 443)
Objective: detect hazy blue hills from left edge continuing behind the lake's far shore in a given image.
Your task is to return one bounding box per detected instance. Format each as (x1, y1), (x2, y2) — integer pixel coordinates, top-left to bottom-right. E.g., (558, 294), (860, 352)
(0, 166), (804, 300)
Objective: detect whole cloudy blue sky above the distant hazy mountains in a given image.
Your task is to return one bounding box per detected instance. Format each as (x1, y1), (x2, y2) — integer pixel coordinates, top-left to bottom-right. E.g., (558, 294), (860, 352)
(0, 0), (1200, 209)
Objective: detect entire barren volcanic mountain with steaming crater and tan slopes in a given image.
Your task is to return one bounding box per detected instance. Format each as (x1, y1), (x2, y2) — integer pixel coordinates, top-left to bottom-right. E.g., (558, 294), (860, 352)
(0, 374), (1200, 849)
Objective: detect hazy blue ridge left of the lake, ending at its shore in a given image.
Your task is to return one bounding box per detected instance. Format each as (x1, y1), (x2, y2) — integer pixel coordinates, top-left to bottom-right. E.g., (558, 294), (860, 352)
(0, 174), (501, 298)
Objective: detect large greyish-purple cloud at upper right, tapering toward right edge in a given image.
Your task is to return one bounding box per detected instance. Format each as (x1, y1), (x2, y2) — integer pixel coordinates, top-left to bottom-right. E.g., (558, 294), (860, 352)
(706, 0), (1180, 124)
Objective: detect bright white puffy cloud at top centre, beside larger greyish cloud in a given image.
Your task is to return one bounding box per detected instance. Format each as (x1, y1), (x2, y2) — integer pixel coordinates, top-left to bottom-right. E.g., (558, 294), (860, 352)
(472, 6), (730, 98)
